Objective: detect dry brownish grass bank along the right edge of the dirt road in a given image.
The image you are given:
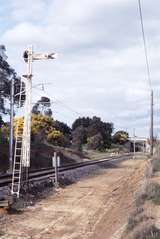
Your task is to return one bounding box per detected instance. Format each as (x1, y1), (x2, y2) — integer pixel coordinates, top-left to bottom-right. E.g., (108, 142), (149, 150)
(122, 157), (160, 239)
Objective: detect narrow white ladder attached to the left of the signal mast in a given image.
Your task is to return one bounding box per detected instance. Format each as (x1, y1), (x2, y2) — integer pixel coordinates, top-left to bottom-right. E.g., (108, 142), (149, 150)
(11, 81), (25, 198)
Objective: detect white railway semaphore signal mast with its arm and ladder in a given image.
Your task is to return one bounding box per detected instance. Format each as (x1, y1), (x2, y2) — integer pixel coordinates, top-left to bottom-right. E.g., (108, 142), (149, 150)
(11, 46), (56, 197)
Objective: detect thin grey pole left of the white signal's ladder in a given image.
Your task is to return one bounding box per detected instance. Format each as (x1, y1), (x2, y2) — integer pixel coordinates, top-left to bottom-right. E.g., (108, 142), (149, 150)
(9, 75), (14, 172)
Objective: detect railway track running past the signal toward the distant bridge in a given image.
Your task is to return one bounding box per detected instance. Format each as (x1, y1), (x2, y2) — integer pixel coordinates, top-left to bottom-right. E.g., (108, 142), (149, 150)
(0, 154), (133, 187)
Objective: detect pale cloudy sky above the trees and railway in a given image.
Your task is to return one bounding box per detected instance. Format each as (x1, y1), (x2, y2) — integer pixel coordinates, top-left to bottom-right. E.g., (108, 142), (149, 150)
(0, 0), (160, 136)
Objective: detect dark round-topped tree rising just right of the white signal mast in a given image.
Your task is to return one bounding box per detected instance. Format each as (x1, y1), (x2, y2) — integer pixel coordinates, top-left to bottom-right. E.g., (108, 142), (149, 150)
(32, 96), (52, 116)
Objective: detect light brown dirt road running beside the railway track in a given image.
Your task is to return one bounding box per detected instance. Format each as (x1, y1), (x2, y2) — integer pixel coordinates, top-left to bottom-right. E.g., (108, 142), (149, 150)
(0, 160), (146, 239)
